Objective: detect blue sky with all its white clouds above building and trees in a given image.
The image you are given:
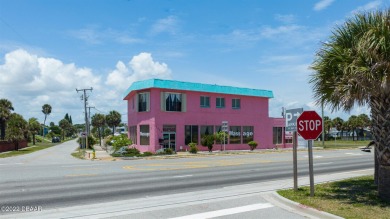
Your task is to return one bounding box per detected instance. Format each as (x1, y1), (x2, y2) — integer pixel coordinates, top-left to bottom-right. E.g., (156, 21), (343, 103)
(0, 0), (390, 123)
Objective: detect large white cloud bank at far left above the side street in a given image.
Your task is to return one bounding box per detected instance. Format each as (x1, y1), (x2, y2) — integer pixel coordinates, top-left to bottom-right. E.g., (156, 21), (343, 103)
(0, 49), (101, 122)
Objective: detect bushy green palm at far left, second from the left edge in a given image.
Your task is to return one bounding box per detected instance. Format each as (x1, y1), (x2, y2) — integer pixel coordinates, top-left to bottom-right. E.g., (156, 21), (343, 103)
(6, 113), (28, 150)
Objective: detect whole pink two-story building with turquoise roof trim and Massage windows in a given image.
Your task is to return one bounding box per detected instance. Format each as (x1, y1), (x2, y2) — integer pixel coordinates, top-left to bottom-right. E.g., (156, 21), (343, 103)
(124, 79), (286, 152)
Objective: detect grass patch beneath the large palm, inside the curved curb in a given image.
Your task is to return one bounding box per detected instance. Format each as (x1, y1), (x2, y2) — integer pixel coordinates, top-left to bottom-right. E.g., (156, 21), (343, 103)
(278, 176), (390, 219)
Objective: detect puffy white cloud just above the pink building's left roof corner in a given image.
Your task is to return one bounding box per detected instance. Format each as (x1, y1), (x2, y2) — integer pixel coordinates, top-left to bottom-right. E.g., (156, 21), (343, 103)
(106, 52), (171, 92)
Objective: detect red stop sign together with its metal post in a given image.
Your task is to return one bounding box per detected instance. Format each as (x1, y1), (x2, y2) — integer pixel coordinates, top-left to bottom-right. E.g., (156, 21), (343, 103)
(297, 111), (322, 196)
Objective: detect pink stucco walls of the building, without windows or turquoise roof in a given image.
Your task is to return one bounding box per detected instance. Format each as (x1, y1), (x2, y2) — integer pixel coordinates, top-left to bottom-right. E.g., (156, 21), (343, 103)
(126, 88), (284, 152)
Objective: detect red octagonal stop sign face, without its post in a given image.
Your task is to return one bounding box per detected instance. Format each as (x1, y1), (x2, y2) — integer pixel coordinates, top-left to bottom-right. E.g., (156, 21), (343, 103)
(297, 111), (322, 140)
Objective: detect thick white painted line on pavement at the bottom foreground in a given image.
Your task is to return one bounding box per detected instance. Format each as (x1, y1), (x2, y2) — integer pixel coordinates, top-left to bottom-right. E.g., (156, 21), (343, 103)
(171, 203), (274, 219)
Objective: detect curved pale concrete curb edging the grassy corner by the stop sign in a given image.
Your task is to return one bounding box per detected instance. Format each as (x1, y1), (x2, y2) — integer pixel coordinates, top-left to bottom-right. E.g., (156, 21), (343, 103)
(263, 191), (342, 219)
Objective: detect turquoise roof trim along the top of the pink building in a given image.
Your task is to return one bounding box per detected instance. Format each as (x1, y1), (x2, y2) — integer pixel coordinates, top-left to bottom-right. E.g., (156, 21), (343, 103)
(124, 79), (274, 99)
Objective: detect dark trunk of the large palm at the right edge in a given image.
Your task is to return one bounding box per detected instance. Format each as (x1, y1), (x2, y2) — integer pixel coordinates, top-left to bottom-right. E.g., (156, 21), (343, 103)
(370, 93), (390, 201)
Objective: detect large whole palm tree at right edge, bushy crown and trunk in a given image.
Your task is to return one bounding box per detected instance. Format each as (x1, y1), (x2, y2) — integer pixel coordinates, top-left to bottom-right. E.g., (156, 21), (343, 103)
(310, 9), (390, 200)
